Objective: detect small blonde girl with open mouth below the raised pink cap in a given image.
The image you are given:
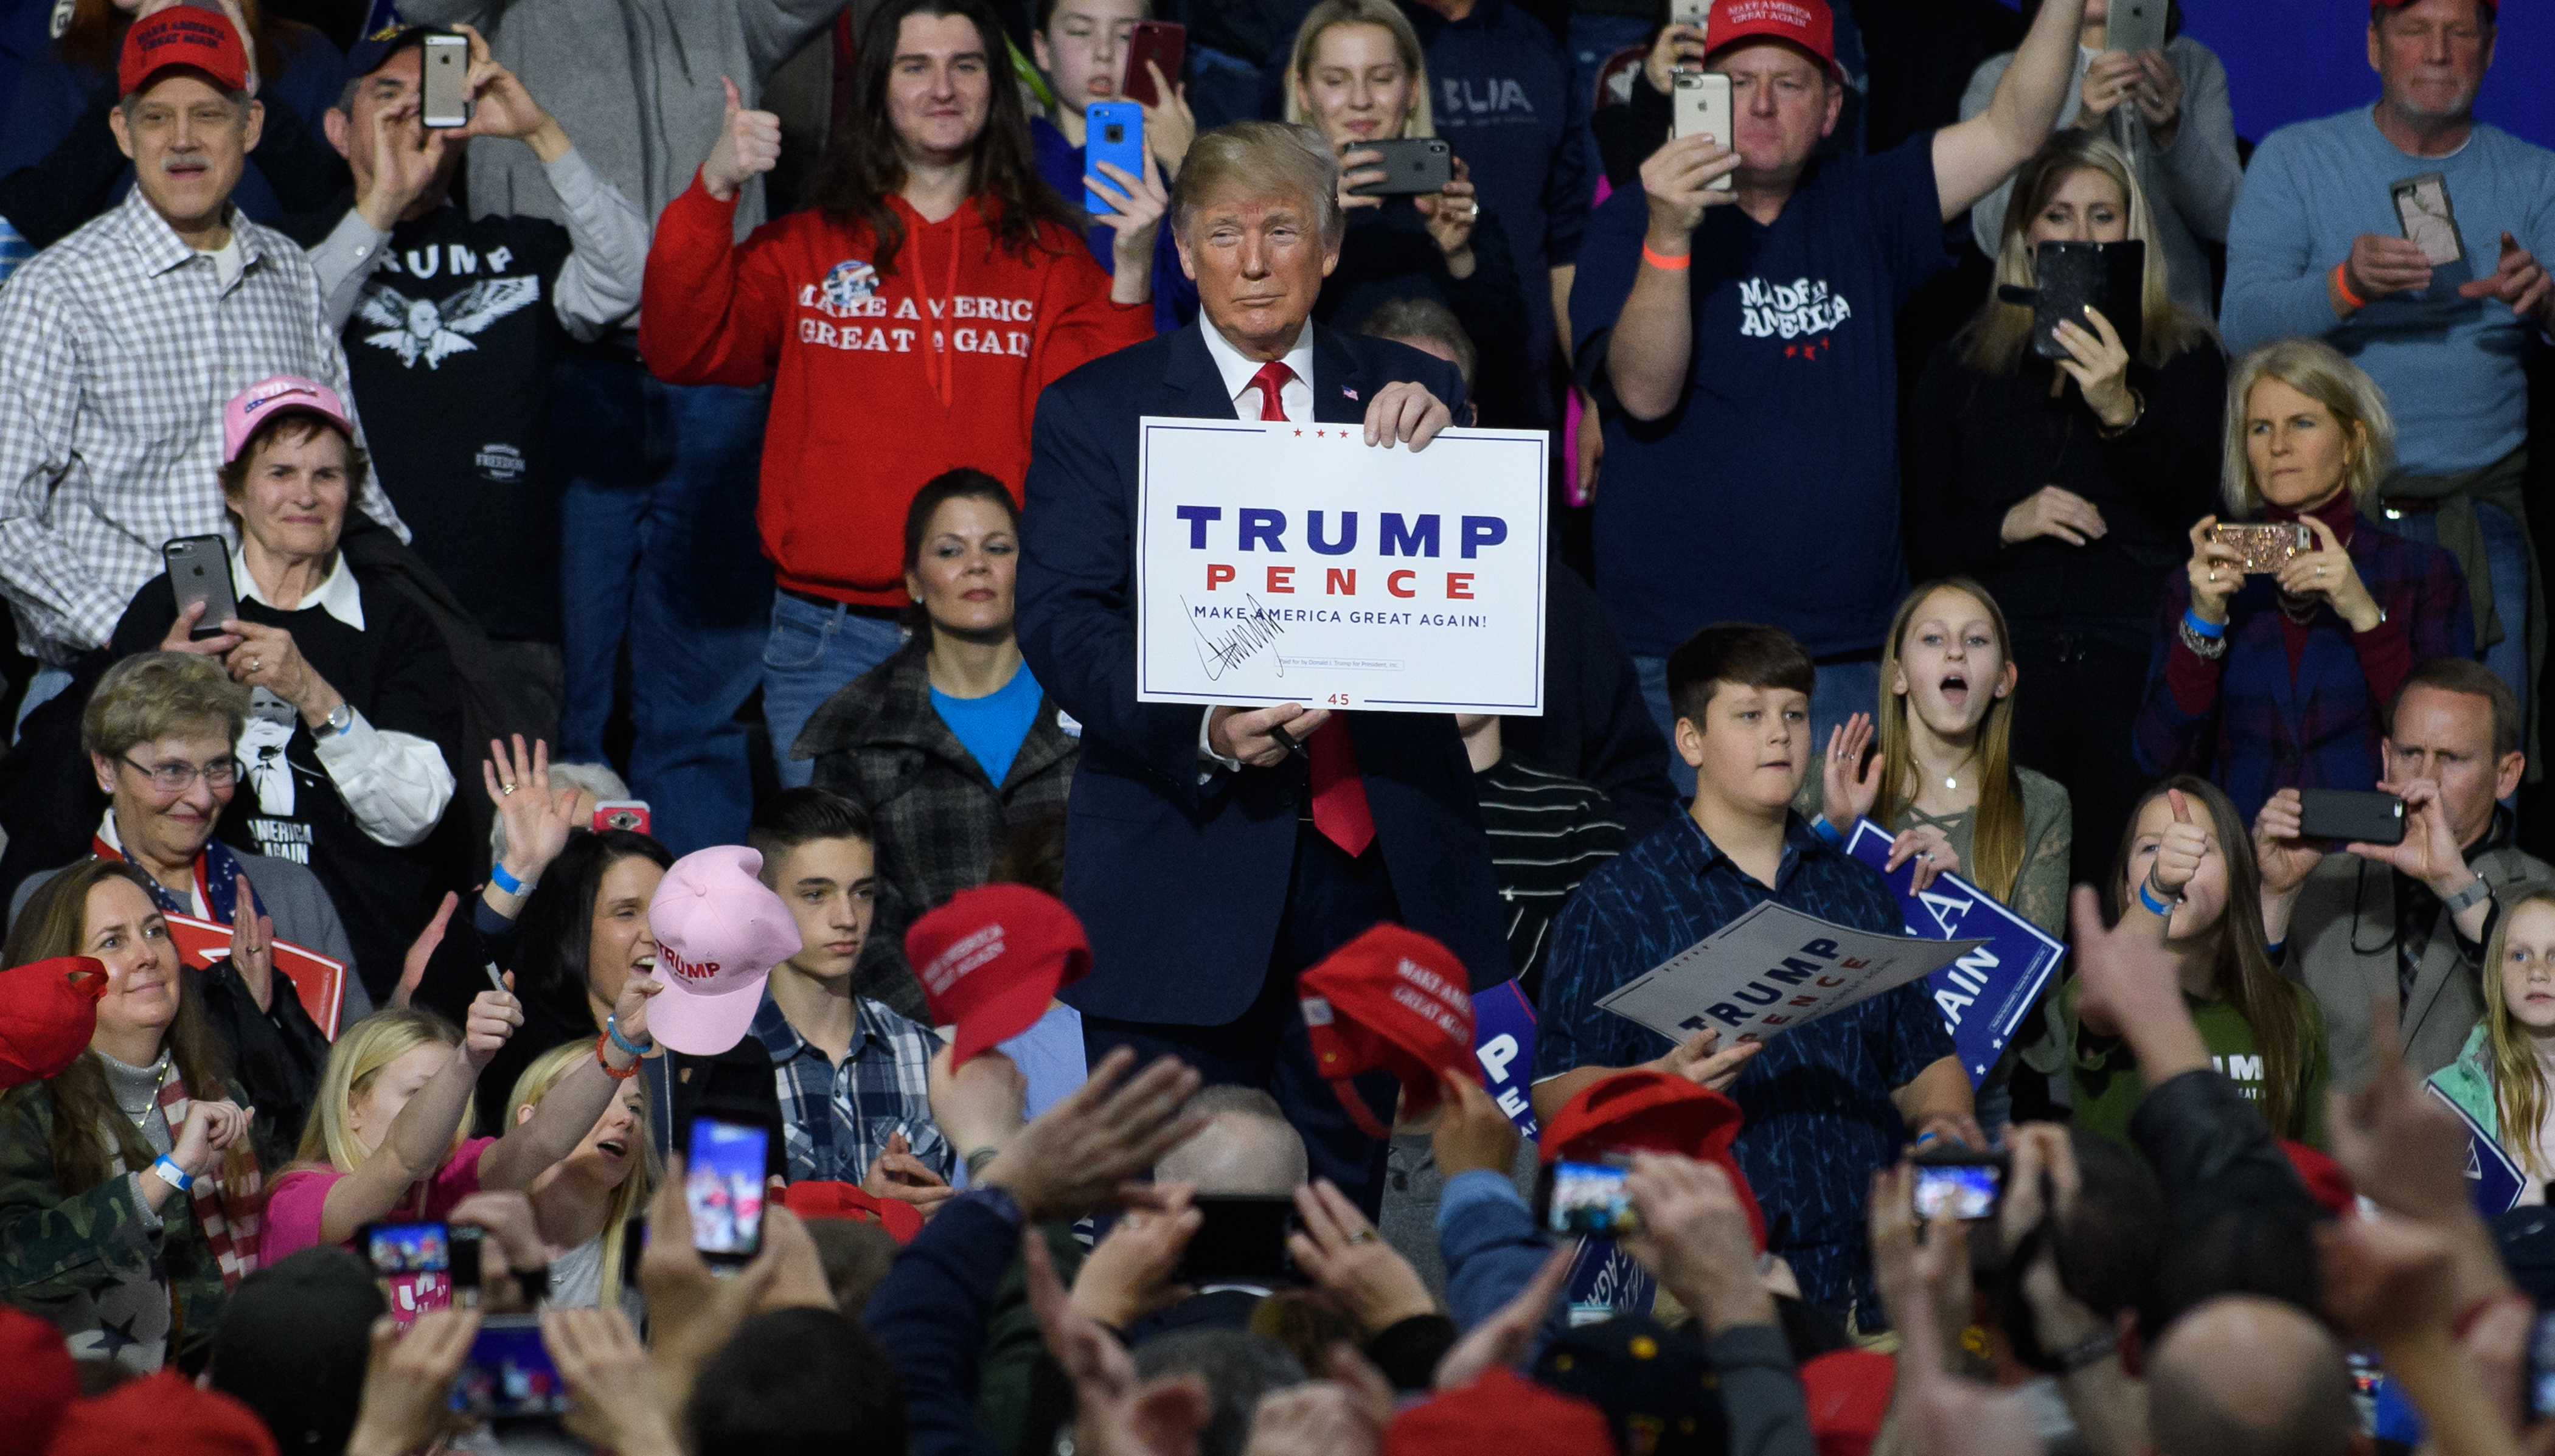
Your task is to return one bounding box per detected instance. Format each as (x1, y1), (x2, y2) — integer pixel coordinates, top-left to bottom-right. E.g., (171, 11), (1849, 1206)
(506, 1042), (659, 1320)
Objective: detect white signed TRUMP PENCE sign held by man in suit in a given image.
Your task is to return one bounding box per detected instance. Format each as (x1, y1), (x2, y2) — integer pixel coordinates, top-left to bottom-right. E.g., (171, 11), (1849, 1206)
(1137, 417), (1548, 715)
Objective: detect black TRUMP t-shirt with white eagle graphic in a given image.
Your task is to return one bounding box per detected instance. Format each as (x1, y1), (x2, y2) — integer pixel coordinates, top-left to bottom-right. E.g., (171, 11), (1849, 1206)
(342, 204), (570, 643)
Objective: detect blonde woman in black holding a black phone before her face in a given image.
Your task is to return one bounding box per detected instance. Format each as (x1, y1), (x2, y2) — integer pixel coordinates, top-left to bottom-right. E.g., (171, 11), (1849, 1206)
(1903, 128), (2225, 873)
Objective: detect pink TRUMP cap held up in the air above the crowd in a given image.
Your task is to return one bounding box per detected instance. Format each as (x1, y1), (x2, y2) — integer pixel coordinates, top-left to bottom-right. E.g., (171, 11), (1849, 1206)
(647, 845), (800, 1058)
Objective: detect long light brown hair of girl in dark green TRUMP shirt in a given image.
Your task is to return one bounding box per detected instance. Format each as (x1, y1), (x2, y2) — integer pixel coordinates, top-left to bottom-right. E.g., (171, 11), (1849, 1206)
(2103, 774), (2307, 1137)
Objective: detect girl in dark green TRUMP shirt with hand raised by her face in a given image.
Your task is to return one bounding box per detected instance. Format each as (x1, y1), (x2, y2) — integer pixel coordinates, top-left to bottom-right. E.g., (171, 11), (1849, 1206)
(2059, 774), (2327, 1147)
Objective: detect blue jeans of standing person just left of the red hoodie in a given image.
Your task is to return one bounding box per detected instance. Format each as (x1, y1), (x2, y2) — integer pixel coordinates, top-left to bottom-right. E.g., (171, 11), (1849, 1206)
(549, 350), (771, 856)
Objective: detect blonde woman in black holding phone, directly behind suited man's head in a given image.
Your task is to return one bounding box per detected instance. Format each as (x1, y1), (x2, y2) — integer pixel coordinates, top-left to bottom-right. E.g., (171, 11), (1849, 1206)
(1285, 0), (1525, 424)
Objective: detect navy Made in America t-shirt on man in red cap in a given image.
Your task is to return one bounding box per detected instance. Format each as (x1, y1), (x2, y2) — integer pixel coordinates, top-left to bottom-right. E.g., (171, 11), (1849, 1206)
(1571, 133), (1950, 656)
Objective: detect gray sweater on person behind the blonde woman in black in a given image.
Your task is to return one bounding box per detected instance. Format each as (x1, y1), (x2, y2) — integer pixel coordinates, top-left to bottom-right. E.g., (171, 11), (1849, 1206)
(1959, 36), (2244, 319)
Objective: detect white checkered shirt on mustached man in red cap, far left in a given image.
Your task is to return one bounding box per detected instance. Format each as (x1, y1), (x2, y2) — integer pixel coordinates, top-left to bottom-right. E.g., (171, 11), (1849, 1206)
(0, 187), (409, 667)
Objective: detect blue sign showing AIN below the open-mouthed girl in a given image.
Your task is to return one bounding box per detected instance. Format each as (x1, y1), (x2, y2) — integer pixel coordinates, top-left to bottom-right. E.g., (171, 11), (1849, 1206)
(1844, 820), (2067, 1088)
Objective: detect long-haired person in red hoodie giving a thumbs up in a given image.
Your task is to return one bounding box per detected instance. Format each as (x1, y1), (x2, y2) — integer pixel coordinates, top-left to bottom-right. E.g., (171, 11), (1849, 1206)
(639, 0), (1170, 787)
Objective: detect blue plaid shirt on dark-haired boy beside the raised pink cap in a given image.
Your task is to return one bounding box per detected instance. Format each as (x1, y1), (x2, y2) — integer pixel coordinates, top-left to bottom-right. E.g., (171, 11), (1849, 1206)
(754, 991), (958, 1183)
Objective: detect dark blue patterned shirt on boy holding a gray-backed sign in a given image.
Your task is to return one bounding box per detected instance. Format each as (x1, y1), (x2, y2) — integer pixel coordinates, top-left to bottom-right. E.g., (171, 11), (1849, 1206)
(1535, 815), (1955, 1313)
